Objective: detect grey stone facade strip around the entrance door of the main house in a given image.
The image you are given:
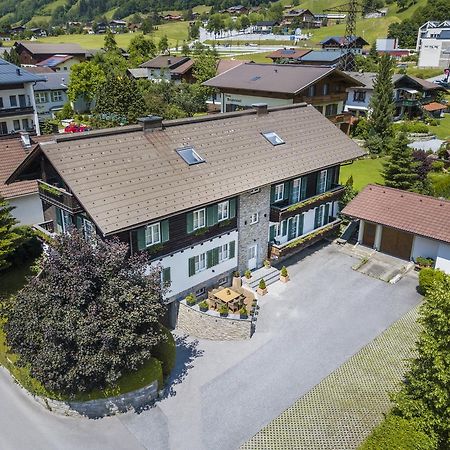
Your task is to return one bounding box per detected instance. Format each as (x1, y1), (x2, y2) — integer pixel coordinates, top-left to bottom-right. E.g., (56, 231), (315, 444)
(238, 186), (270, 273)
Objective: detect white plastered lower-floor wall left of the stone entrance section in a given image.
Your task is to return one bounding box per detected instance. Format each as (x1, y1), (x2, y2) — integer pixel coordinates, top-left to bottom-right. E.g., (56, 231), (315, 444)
(151, 230), (238, 297)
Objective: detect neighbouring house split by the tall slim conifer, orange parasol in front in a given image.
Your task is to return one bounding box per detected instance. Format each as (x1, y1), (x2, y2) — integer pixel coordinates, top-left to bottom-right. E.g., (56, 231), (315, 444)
(344, 72), (447, 117)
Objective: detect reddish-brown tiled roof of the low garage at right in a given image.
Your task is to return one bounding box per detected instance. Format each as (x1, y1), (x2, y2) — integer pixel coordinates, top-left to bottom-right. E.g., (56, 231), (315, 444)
(342, 184), (450, 242)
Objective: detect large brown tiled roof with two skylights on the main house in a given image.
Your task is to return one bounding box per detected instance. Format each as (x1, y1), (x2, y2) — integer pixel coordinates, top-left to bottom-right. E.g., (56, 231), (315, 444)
(11, 104), (364, 234)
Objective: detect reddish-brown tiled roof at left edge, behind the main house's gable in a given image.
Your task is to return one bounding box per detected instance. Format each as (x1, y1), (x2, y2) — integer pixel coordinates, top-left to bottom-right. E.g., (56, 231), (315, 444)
(0, 137), (38, 199)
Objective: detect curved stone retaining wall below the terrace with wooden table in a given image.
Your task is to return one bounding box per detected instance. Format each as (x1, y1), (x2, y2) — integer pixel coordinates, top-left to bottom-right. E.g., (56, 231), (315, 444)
(177, 302), (251, 341)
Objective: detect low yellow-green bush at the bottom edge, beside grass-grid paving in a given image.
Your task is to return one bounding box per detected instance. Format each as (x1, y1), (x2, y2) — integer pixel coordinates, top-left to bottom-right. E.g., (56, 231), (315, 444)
(359, 414), (436, 450)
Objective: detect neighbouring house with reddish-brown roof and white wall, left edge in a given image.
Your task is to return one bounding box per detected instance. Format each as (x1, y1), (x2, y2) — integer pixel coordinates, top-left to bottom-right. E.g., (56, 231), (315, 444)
(0, 133), (44, 225)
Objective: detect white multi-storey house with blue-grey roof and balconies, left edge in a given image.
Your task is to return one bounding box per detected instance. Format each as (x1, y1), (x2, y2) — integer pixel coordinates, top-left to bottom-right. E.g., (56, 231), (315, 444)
(0, 59), (45, 136)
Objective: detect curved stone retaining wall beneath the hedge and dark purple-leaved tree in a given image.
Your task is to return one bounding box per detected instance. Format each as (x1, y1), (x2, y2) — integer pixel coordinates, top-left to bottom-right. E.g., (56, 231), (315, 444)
(33, 381), (159, 419)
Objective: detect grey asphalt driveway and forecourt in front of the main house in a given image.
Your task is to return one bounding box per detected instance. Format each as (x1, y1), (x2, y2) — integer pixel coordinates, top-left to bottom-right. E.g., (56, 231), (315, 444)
(0, 245), (420, 450)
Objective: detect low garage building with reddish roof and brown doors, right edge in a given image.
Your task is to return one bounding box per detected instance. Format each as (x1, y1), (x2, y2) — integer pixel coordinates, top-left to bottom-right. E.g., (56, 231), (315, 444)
(342, 185), (450, 274)
